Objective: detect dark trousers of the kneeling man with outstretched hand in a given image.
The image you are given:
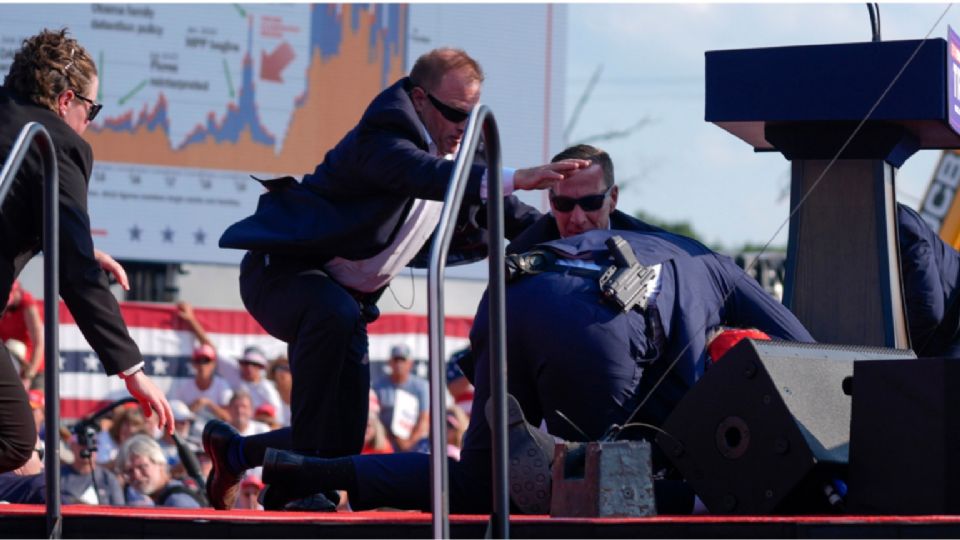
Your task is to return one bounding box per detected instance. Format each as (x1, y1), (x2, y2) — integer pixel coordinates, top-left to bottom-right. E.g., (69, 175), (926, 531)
(240, 252), (370, 456)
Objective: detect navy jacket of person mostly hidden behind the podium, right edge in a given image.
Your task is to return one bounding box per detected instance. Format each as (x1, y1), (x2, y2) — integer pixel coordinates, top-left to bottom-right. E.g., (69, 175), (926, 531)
(897, 204), (960, 357)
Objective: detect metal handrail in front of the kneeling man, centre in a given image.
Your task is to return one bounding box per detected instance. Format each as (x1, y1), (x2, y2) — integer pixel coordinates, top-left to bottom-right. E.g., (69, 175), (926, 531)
(427, 105), (510, 538)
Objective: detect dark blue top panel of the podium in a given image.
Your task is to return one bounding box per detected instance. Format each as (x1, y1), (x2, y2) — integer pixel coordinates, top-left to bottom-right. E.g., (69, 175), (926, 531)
(705, 39), (960, 150)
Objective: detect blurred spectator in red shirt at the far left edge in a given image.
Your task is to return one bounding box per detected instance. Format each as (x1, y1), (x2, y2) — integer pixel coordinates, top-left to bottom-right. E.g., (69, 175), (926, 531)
(0, 281), (43, 390)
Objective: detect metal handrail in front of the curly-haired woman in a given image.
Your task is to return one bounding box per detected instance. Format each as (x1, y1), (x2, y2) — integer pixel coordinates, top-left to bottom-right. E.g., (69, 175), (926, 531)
(0, 122), (63, 538)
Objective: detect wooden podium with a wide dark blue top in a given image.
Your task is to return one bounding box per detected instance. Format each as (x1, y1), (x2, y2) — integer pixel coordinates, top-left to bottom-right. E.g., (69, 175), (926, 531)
(705, 39), (960, 348)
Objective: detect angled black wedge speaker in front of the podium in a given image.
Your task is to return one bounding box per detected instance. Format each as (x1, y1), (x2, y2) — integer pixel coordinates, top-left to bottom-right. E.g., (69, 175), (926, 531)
(657, 340), (914, 514)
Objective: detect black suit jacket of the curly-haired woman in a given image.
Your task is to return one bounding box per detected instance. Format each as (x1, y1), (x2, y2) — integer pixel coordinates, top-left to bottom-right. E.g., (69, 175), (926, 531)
(0, 88), (141, 375)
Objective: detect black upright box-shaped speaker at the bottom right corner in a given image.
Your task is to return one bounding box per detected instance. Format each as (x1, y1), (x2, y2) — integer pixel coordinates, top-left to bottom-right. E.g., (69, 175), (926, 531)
(849, 358), (960, 514)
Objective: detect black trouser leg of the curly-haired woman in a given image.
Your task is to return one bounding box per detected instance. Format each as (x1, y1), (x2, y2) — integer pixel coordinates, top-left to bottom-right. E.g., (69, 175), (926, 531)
(0, 345), (37, 473)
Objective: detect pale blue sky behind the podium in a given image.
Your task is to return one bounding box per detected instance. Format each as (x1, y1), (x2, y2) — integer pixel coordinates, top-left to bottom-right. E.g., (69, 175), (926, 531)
(565, 3), (960, 250)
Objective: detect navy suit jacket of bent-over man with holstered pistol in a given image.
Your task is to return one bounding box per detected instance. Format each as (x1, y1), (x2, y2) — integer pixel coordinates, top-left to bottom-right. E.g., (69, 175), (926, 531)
(528, 230), (814, 425)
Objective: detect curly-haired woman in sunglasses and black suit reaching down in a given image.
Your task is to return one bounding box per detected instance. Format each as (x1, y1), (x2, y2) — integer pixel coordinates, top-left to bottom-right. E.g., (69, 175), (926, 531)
(0, 30), (173, 472)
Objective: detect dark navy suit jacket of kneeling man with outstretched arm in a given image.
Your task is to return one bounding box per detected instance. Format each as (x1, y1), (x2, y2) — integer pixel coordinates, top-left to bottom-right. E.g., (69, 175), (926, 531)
(220, 78), (536, 262)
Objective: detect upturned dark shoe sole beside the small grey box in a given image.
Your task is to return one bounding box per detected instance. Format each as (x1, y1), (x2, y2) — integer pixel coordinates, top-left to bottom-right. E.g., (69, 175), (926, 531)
(484, 394), (556, 514)
